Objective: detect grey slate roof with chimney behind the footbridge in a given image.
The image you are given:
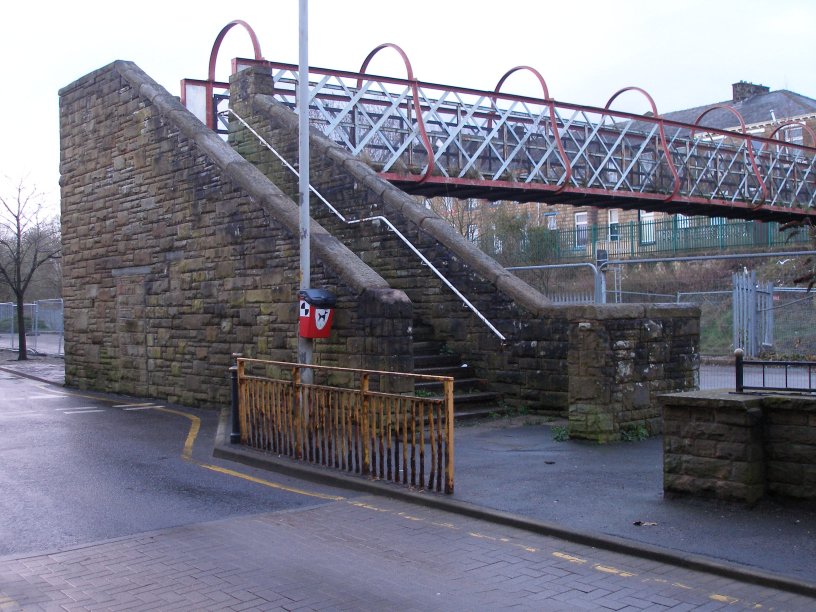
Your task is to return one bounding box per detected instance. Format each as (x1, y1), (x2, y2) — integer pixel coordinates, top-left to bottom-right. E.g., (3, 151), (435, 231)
(662, 81), (816, 129)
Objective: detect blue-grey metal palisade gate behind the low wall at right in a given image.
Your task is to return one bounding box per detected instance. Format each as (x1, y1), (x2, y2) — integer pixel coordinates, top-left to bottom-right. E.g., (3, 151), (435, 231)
(733, 270), (774, 358)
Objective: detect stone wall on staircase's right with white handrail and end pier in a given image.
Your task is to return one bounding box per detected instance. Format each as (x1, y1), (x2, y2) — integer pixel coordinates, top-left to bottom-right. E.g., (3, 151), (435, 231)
(230, 69), (699, 441)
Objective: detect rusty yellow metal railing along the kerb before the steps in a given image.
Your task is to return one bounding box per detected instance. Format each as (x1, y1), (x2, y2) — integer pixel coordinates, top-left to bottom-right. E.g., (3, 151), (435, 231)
(234, 358), (453, 493)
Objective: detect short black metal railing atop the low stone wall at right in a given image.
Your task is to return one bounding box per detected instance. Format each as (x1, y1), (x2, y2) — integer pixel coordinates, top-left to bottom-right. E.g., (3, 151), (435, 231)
(734, 349), (816, 393)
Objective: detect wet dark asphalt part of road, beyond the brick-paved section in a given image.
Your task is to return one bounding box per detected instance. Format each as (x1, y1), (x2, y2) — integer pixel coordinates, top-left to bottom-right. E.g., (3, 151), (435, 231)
(0, 372), (347, 555)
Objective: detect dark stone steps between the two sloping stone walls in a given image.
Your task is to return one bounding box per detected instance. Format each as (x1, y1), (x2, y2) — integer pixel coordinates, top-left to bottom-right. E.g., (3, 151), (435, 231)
(413, 321), (503, 420)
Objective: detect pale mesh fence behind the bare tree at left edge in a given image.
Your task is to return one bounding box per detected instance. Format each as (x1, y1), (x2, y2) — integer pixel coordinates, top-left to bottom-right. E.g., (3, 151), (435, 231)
(0, 299), (65, 355)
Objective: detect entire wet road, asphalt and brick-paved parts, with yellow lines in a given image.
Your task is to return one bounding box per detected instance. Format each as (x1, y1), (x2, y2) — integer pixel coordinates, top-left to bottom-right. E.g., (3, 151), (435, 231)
(0, 371), (814, 612)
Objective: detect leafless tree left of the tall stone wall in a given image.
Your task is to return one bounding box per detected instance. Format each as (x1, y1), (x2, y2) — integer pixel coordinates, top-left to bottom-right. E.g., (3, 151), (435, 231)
(0, 181), (60, 360)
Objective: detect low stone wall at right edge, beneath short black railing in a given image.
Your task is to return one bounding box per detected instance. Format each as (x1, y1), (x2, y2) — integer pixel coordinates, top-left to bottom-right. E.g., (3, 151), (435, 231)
(661, 391), (816, 504)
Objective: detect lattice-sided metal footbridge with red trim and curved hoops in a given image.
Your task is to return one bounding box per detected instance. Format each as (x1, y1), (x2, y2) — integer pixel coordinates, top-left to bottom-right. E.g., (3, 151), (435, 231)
(182, 22), (816, 222)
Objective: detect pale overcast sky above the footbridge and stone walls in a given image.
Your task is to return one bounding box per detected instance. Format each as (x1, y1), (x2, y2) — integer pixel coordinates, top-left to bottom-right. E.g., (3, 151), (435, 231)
(0, 0), (816, 210)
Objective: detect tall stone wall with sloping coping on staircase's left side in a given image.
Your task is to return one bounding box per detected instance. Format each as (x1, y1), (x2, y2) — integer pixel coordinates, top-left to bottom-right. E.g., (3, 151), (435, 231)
(60, 62), (413, 406)
